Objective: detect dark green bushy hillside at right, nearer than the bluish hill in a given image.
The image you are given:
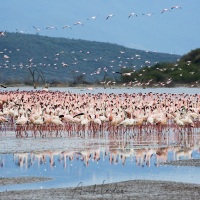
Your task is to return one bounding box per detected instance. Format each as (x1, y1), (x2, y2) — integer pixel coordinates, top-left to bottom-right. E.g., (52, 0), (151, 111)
(121, 48), (200, 87)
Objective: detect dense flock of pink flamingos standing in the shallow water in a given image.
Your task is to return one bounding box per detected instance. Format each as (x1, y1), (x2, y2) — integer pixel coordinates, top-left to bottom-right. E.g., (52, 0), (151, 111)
(0, 90), (200, 137)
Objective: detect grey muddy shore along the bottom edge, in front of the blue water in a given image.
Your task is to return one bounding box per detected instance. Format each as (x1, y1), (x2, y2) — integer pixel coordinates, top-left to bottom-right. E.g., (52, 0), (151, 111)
(0, 180), (200, 200)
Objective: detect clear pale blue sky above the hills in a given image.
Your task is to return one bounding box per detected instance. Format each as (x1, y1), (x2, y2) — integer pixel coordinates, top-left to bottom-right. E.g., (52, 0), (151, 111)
(0, 0), (200, 55)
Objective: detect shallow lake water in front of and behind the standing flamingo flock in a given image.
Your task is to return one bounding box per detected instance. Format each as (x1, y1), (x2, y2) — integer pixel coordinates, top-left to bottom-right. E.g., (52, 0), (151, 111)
(0, 87), (200, 191)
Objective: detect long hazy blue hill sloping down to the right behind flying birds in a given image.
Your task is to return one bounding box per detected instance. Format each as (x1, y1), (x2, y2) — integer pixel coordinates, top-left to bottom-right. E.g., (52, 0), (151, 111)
(0, 33), (180, 84)
